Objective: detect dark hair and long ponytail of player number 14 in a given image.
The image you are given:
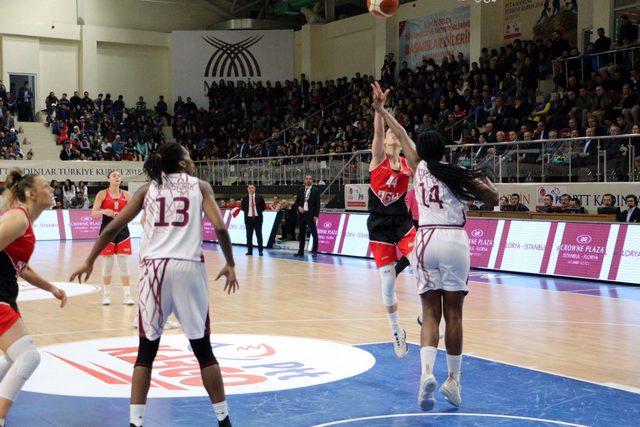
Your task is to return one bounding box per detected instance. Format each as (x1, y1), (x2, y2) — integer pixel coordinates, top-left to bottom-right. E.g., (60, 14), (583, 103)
(416, 131), (483, 200)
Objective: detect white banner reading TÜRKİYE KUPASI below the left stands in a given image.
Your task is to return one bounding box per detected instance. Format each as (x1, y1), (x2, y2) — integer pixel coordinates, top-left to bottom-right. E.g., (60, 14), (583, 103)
(0, 160), (146, 182)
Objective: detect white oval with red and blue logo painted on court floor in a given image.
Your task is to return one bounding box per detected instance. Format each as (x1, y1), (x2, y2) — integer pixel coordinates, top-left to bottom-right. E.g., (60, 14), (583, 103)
(24, 334), (376, 398)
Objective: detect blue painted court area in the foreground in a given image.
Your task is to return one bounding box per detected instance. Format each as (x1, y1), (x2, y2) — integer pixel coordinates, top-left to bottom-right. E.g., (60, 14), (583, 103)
(7, 343), (640, 427)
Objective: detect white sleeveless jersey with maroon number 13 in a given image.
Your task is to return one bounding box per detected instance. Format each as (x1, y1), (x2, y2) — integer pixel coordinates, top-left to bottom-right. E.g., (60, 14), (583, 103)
(140, 173), (202, 261)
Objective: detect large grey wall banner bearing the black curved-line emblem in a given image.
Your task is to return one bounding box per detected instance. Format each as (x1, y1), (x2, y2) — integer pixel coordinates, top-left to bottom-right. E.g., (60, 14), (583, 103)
(171, 30), (294, 108)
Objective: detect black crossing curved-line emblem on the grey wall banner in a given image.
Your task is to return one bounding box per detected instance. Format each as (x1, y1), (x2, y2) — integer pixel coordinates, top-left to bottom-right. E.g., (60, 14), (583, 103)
(202, 36), (262, 77)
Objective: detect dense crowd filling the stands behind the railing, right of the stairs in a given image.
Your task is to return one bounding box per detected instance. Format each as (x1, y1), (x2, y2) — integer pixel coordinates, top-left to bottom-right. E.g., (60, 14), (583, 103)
(42, 19), (640, 180)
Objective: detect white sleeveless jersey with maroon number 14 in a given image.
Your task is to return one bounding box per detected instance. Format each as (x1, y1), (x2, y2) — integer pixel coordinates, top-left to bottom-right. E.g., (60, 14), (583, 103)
(413, 161), (467, 227)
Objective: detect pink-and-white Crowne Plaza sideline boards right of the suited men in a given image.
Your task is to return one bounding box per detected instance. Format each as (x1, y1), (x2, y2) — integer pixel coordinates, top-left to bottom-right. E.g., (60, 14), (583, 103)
(309, 213), (640, 284)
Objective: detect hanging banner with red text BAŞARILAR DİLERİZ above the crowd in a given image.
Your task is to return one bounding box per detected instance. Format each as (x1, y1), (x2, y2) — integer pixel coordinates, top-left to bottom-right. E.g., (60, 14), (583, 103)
(400, 5), (471, 69)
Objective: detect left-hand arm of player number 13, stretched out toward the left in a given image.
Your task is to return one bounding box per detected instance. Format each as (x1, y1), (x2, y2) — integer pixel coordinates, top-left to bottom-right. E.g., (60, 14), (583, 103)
(69, 184), (149, 283)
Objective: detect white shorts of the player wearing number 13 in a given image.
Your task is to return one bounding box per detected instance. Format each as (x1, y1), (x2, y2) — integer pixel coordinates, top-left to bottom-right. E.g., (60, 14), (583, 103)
(138, 258), (210, 341)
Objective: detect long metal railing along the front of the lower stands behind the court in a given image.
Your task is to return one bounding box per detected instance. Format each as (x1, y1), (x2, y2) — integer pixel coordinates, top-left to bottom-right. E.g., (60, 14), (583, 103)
(196, 135), (640, 187)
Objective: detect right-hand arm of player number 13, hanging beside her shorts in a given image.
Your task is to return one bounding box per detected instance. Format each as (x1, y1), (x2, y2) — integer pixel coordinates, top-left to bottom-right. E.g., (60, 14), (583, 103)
(200, 180), (240, 293)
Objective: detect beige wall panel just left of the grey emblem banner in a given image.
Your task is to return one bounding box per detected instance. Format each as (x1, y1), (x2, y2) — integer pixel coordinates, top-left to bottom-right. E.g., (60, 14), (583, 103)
(97, 43), (170, 107)
